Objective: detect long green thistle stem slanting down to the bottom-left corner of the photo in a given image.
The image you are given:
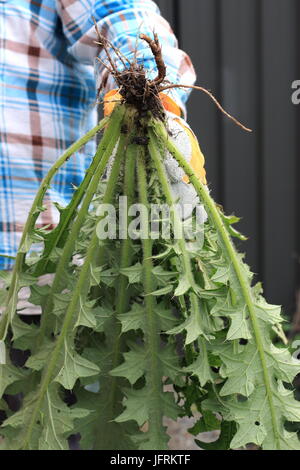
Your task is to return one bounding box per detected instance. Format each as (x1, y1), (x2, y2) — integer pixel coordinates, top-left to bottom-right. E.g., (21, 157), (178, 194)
(22, 120), (125, 449)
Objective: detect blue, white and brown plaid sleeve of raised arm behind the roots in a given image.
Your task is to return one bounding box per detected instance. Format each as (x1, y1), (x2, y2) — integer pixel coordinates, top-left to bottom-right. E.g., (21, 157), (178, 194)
(57, 0), (196, 112)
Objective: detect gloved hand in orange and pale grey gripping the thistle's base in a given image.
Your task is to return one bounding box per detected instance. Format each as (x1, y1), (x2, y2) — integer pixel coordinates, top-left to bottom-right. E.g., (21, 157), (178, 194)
(104, 90), (207, 224)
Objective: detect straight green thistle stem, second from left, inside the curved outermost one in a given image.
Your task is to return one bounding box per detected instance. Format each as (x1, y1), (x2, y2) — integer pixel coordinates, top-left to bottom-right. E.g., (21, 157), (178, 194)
(34, 107), (124, 351)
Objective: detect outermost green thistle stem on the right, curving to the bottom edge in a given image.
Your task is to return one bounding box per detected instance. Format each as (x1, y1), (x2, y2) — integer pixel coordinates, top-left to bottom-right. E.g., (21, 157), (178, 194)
(150, 121), (280, 450)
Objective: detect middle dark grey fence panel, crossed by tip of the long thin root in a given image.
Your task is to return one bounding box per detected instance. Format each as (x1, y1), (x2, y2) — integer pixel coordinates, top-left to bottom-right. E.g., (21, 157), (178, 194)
(221, 0), (262, 275)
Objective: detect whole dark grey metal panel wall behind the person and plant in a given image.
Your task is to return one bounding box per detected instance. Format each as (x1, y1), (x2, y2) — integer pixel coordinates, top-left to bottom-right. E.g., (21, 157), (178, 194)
(157, 0), (300, 312)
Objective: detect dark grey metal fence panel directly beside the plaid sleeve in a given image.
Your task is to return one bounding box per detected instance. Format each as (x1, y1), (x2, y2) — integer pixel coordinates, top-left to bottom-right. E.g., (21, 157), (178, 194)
(179, 0), (222, 200)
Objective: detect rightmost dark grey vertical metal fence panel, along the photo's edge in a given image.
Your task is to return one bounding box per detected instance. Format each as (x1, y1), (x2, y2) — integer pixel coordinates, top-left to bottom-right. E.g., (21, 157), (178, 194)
(261, 0), (298, 309)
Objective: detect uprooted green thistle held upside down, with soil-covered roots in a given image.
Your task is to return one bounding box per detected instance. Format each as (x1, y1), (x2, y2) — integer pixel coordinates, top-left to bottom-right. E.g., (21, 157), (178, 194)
(0, 31), (300, 450)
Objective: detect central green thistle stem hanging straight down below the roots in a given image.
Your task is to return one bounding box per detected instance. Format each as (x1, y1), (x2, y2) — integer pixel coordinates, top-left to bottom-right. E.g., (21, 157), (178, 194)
(137, 148), (163, 450)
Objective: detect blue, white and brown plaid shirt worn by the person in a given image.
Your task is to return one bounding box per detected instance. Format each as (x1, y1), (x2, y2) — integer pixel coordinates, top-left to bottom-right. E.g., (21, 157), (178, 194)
(0, 0), (195, 269)
